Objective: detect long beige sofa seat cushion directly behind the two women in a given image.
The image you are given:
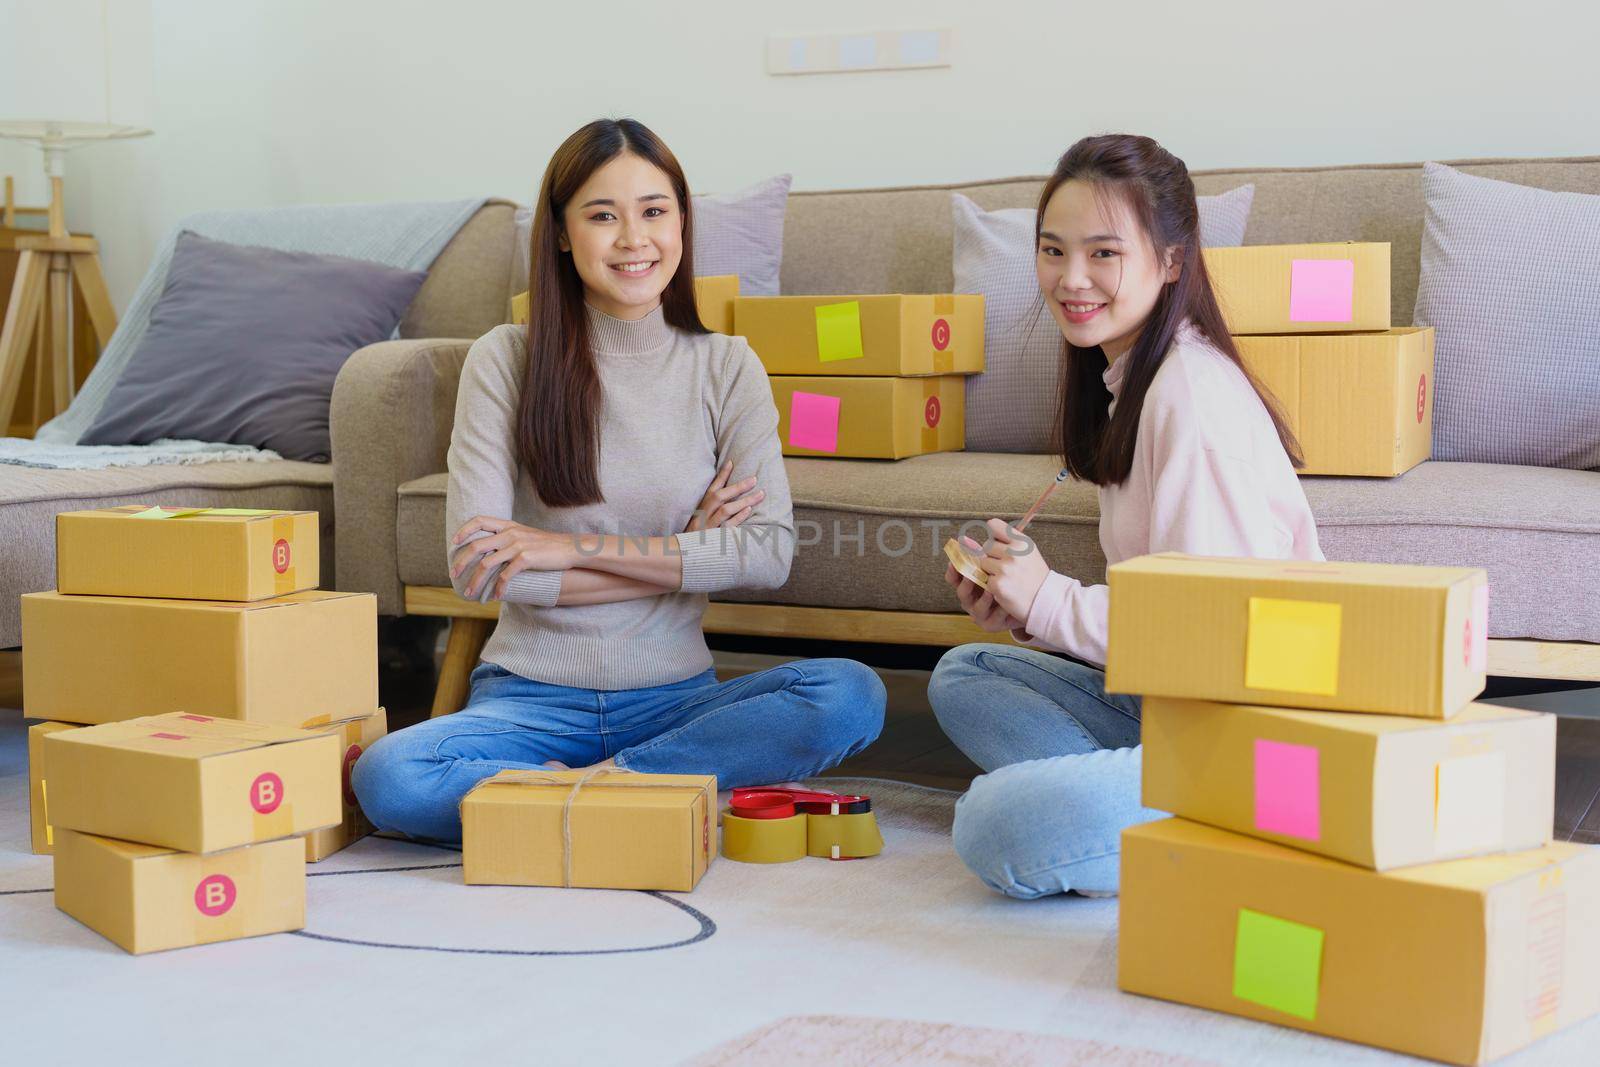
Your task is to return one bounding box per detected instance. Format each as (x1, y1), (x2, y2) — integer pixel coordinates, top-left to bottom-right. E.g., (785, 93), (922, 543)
(398, 453), (1600, 641)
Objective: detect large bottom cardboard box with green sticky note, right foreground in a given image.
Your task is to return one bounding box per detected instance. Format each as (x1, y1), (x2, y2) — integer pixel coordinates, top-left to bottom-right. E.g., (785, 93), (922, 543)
(1117, 819), (1600, 1064)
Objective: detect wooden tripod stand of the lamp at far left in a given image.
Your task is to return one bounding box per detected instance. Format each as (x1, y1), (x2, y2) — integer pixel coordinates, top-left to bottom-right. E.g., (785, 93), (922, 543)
(0, 178), (117, 427)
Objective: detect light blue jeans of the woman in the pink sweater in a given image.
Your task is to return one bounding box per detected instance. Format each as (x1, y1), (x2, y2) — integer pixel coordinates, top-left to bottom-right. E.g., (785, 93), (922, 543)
(928, 645), (1165, 899)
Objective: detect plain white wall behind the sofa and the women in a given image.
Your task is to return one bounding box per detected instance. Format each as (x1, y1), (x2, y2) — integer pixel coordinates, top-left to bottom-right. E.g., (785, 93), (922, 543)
(12, 0), (1600, 307)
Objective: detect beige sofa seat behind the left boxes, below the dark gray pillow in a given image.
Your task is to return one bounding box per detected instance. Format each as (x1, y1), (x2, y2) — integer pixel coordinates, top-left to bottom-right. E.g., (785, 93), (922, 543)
(0, 459), (336, 648)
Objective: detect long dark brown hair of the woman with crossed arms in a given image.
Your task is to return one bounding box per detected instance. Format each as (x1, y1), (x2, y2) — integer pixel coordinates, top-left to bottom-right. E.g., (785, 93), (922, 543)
(515, 118), (706, 507)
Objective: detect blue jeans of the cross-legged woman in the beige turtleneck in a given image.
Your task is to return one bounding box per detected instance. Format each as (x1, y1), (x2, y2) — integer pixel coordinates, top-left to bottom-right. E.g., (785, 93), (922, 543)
(350, 659), (885, 841)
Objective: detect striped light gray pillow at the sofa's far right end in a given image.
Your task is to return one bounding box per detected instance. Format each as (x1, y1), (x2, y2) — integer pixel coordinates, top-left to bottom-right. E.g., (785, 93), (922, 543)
(1414, 163), (1600, 470)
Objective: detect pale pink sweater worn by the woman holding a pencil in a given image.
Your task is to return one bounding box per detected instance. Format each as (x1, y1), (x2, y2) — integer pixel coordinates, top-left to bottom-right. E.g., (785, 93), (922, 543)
(1013, 328), (1323, 664)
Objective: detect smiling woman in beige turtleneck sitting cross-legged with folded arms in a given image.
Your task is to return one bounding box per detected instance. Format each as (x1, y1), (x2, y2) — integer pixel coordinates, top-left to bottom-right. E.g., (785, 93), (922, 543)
(352, 118), (885, 841)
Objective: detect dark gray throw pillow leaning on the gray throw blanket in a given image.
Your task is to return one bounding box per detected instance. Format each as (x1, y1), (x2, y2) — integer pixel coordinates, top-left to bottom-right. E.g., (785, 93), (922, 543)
(78, 230), (427, 462)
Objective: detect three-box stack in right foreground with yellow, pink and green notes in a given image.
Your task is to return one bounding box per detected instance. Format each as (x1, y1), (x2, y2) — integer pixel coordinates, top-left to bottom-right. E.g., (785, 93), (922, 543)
(1106, 553), (1600, 1064)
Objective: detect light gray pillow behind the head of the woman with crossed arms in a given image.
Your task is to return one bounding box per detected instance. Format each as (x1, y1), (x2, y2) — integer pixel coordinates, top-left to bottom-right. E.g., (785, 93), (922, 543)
(512, 174), (790, 296)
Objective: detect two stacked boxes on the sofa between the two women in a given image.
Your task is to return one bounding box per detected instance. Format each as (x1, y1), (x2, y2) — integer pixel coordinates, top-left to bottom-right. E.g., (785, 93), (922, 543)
(733, 294), (984, 459)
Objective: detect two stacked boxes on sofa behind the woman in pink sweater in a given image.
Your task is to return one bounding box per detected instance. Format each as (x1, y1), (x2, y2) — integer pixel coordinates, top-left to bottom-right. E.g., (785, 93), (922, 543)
(1205, 242), (1434, 477)
